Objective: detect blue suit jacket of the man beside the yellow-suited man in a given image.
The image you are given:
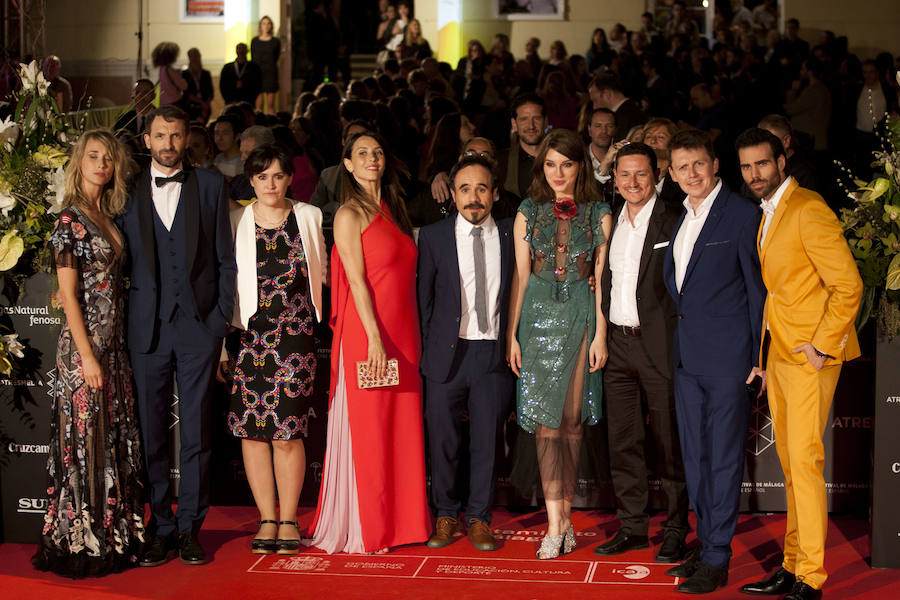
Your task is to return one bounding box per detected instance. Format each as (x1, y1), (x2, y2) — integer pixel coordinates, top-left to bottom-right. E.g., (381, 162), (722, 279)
(665, 183), (766, 377)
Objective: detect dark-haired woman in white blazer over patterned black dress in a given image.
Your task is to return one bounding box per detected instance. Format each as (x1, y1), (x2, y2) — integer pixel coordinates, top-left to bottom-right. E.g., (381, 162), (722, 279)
(221, 144), (327, 554)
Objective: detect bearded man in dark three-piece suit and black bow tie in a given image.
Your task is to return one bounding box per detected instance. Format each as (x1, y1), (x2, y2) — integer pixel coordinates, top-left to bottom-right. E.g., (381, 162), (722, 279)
(118, 105), (236, 567)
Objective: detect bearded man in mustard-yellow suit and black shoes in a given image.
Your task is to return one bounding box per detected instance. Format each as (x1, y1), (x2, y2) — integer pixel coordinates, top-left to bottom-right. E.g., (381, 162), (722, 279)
(735, 128), (863, 600)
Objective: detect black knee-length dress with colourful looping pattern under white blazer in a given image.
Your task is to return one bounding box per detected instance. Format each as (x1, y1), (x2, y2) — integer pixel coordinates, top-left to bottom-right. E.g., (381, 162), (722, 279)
(228, 212), (316, 440)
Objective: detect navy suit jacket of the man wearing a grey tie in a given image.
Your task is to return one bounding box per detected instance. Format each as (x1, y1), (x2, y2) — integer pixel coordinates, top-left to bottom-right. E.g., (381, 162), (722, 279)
(417, 215), (515, 382)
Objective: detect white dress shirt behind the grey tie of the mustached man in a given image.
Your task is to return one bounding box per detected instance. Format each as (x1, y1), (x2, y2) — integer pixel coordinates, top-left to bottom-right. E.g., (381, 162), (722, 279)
(456, 215), (500, 340)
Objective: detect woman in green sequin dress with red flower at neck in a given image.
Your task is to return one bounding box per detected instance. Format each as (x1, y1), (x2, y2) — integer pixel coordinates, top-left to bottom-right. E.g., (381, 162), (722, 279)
(507, 129), (612, 558)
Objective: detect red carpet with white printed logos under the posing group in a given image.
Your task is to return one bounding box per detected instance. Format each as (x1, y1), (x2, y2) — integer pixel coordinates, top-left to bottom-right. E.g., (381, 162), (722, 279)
(0, 507), (900, 600)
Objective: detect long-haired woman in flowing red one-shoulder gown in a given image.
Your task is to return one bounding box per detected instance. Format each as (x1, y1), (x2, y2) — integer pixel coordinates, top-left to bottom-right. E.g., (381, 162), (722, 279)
(307, 132), (431, 553)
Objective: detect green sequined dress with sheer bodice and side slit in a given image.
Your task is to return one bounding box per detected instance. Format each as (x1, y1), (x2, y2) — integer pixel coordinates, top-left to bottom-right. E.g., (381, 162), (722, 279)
(516, 198), (610, 433)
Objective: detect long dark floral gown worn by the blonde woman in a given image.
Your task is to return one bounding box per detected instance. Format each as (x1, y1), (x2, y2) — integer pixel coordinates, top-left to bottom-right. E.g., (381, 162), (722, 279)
(32, 206), (144, 577)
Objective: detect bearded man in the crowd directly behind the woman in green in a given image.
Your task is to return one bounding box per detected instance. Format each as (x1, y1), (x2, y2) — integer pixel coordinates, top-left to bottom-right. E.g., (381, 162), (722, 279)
(497, 93), (547, 198)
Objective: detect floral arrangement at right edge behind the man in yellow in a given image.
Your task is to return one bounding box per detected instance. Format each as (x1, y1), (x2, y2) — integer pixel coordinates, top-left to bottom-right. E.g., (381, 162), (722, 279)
(837, 80), (900, 339)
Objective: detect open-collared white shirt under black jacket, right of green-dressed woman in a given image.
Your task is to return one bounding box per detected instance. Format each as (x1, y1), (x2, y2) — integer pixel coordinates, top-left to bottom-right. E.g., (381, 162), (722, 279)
(609, 194), (656, 327)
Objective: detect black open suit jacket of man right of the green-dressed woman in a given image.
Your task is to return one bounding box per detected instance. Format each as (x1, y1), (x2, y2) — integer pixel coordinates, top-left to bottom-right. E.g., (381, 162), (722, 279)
(601, 196), (681, 378)
